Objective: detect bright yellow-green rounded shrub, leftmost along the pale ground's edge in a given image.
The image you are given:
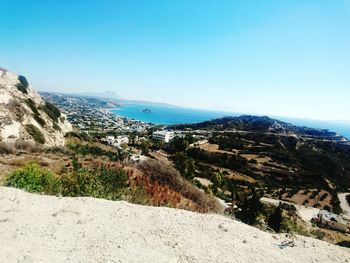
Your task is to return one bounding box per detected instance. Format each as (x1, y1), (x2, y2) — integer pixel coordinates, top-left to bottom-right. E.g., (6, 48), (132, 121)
(5, 163), (60, 195)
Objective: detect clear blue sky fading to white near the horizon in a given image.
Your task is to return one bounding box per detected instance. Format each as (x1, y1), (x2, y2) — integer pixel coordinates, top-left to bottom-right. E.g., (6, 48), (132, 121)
(0, 0), (350, 120)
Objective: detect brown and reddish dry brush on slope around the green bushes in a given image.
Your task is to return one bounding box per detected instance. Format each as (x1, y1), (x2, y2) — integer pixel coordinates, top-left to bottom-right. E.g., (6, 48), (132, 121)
(0, 140), (223, 212)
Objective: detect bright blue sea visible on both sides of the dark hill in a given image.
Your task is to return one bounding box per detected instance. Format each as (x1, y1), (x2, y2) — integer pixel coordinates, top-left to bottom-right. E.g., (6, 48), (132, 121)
(111, 102), (350, 139)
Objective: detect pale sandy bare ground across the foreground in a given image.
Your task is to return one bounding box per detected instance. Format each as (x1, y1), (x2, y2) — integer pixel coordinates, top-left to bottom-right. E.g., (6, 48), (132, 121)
(0, 187), (350, 263)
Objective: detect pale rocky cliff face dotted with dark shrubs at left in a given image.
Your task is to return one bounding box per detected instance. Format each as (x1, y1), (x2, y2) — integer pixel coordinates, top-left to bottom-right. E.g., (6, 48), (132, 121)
(0, 68), (72, 146)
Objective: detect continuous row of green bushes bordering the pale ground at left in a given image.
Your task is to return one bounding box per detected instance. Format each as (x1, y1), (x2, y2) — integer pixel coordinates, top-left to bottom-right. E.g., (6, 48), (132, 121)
(5, 162), (128, 200)
